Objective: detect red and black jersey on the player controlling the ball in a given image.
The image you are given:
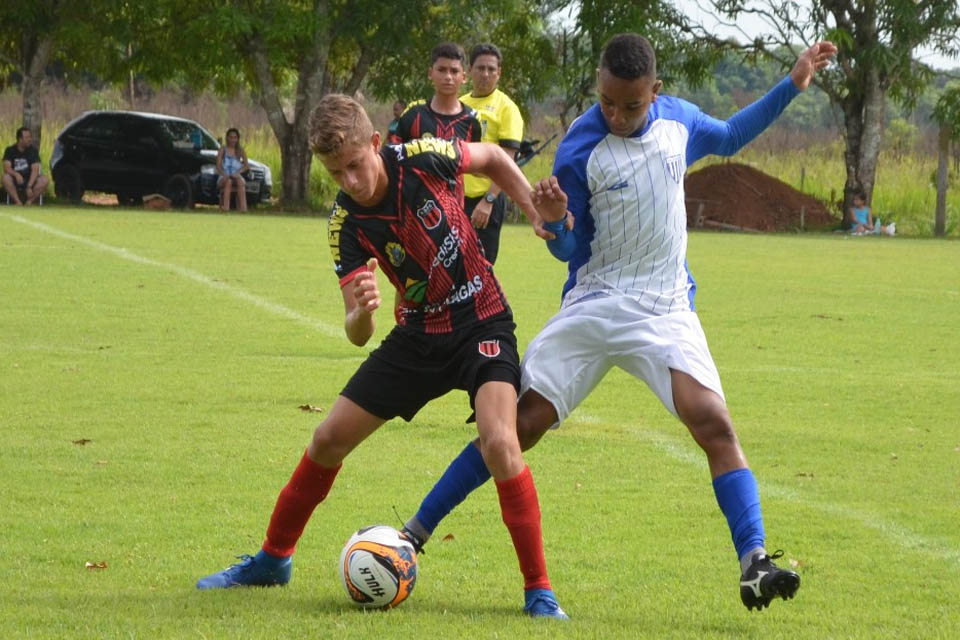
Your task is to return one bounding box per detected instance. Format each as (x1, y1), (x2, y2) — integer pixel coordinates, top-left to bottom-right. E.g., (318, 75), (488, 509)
(328, 138), (508, 334)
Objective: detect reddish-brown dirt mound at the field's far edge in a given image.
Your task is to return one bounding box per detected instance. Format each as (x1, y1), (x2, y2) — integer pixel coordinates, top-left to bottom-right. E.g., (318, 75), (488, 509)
(684, 163), (836, 231)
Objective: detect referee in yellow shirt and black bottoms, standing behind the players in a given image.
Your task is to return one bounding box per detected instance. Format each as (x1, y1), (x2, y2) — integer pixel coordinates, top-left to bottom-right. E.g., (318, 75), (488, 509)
(460, 43), (523, 264)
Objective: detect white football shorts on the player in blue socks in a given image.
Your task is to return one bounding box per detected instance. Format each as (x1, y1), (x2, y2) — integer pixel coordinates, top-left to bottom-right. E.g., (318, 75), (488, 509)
(520, 295), (724, 428)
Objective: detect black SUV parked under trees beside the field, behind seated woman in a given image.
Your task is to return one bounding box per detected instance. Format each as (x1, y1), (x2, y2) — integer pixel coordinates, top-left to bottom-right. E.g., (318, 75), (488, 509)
(50, 111), (273, 209)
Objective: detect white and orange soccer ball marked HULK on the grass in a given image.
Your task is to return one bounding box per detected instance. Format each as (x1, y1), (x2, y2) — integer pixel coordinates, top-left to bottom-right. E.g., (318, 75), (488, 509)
(340, 524), (417, 609)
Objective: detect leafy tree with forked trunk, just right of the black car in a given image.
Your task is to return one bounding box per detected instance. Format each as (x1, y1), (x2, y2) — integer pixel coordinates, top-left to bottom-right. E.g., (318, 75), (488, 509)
(151, 0), (556, 206)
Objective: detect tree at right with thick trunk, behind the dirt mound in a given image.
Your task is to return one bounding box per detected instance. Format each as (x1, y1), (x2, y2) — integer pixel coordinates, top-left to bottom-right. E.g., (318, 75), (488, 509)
(691, 0), (960, 215)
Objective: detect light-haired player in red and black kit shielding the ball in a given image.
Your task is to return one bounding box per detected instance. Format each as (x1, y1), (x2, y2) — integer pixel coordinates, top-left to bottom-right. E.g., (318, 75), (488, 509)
(197, 94), (567, 619)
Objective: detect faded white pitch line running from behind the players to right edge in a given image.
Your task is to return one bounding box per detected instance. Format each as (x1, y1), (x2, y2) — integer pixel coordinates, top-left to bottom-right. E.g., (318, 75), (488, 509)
(571, 412), (960, 566)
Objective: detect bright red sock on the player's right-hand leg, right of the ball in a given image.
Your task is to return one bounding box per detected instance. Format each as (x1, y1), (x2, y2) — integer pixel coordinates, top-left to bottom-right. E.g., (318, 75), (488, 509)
(496, 467), (550, 590)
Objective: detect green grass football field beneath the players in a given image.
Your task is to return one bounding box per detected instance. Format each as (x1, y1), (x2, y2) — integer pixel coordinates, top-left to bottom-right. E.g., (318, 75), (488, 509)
(0, 207), (960, 640)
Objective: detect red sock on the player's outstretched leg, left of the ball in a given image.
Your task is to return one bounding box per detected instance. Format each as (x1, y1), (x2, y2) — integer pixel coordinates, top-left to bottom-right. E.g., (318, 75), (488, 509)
(263, 452), (343, 558)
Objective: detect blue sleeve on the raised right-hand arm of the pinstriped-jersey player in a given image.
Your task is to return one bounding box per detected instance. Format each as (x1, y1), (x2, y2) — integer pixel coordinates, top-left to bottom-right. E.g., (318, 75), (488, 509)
(687, 76), (800, 166)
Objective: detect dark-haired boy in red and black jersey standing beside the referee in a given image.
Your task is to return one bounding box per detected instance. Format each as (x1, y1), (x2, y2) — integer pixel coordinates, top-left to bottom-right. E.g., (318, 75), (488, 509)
(389, 42), (483, 144)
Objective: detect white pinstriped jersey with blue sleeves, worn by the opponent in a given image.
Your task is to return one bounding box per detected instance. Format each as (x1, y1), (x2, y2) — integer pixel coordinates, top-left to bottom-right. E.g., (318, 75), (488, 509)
(551, 76), (799, 315)
